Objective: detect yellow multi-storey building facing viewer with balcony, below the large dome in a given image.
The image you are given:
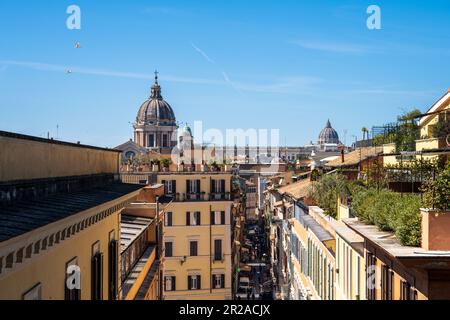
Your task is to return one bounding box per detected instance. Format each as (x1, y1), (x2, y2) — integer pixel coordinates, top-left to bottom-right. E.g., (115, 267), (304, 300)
(157, 172), (233, 300)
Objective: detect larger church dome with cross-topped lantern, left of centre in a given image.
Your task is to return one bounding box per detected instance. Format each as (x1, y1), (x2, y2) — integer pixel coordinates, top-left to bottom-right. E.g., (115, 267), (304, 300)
(136, 75), (176, 126)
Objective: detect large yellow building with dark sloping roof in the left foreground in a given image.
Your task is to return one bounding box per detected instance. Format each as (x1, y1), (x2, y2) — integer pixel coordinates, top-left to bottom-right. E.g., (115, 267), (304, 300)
(0, 132), (141, 300)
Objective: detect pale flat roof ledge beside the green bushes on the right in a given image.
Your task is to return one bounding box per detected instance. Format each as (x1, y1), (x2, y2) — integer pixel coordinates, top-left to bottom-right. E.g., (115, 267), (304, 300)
(343, 219), (450, 259)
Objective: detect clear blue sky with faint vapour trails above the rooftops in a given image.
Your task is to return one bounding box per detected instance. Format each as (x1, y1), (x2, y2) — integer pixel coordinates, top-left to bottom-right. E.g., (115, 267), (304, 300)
(0, 0), (450, 147)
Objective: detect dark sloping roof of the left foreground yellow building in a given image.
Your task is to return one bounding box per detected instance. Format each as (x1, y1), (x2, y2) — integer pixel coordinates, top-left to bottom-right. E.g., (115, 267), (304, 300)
(0, 183), (142, 242)
